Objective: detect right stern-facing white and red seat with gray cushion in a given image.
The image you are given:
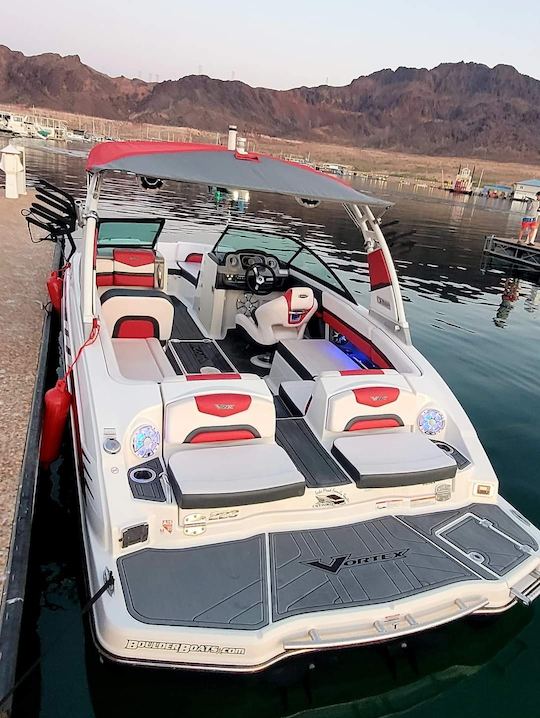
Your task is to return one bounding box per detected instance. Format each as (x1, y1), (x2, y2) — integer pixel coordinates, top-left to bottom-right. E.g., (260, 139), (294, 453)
(307, 369), (457, 488)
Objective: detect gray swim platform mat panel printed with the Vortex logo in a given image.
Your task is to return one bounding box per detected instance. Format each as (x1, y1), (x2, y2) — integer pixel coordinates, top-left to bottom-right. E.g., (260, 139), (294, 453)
(270, 516), (478, 621)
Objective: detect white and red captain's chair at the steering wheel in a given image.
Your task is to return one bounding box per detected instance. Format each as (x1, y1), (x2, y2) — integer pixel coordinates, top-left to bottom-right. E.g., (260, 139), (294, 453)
(235, 287), (317, 346)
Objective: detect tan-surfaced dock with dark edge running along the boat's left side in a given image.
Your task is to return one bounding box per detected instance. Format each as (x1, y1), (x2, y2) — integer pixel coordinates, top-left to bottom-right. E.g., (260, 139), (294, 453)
(0, 194), (54, 716)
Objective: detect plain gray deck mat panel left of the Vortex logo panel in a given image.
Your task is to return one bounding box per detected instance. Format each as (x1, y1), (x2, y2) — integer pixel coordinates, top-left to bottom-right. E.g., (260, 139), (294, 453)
(118, 535), (268, 629)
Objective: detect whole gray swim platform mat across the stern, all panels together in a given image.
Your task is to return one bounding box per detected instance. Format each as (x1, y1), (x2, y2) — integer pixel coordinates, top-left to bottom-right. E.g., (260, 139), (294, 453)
(118, 506), (538, 630)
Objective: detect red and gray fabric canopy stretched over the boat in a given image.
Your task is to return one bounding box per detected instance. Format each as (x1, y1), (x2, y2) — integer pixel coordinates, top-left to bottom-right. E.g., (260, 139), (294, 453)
(86, 141), (391, 207)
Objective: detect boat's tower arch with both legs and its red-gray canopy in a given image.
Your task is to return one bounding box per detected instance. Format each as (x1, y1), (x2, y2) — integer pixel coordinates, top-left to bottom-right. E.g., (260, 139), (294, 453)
(81, 141), (410, 343)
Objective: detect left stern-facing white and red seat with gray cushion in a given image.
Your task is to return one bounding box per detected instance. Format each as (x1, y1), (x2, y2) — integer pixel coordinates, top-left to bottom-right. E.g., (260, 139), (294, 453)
(162, 374), (305, 509)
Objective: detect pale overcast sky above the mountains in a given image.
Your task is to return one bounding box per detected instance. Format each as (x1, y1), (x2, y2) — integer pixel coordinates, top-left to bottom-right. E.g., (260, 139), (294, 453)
(0, 0), (540, 89)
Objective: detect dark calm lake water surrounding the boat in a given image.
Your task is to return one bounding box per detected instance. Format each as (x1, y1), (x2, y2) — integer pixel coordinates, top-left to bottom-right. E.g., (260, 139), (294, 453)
(10, 139), (540, 718)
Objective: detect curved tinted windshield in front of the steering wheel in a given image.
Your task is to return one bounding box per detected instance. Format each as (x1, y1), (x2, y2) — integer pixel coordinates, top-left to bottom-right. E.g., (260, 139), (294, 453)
(213, 227), (354, 301)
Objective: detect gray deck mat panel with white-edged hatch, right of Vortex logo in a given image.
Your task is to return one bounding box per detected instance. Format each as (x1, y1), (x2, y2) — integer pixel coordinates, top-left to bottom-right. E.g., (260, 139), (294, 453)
(400, 504), (538, 580)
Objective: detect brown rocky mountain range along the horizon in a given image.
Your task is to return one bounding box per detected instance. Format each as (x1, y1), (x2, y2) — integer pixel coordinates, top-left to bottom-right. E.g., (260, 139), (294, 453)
(0, 46), (540, 162)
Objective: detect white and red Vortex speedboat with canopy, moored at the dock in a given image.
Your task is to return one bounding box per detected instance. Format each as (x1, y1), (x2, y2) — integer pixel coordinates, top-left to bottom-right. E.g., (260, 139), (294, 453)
(47, 142), (540, 672)
